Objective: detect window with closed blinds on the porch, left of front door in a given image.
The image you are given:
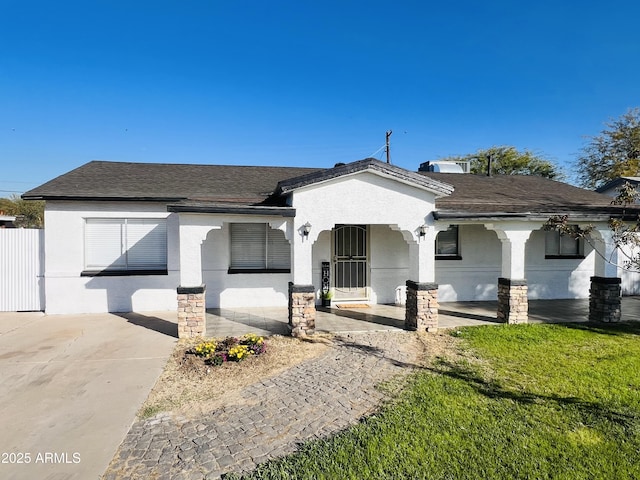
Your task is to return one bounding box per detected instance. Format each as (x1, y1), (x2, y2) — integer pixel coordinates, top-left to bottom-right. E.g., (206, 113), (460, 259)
(230, 223), (291, 271)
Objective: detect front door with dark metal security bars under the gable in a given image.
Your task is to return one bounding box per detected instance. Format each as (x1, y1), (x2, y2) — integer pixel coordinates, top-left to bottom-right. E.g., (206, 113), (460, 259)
(333, 225), (369, 300)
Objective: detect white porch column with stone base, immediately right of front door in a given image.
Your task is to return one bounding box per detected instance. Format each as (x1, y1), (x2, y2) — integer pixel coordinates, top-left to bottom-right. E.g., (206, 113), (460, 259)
(403, 225), (438, 332)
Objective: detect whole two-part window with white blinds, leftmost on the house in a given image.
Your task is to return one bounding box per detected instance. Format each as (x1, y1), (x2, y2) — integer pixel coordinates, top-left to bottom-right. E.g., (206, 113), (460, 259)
(85, 218), (167, 270)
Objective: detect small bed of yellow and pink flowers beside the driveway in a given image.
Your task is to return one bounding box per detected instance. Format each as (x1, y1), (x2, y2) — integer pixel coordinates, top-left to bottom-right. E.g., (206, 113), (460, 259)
(186, 333), (267, 366)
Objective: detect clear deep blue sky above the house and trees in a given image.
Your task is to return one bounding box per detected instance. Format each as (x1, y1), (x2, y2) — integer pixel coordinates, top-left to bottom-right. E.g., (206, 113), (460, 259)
(0, 0), (640, 196)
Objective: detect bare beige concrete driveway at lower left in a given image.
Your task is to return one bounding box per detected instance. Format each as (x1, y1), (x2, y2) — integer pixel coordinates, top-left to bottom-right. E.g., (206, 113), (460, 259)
(0, 312), (177, 480)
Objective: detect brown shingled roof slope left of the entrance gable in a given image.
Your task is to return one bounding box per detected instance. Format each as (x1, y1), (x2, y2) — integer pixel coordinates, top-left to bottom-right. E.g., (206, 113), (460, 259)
(23, 161), (318, 205)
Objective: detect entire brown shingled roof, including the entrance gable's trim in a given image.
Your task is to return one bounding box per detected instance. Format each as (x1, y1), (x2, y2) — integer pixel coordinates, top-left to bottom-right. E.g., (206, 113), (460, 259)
(23, 158), (640, 219)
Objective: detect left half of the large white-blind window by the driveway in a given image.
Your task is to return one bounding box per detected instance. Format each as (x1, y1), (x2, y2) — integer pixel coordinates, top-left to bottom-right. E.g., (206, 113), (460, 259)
(85, 218), (126, 269)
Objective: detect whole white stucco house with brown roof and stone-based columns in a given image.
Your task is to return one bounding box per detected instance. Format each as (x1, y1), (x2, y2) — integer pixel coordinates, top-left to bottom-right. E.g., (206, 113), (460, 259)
(23, 159), (632, 336)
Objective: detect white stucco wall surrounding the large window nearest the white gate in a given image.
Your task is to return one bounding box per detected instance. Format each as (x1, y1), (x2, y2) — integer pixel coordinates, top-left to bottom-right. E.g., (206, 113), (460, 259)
(45, 201), (179, 314)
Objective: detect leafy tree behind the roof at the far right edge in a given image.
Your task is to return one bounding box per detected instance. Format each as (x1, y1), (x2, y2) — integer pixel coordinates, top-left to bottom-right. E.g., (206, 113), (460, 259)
(576, 108), (640, 189)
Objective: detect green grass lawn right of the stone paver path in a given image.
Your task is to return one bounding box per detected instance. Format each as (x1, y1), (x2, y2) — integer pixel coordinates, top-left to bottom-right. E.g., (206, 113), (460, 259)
(228, 324), (640, 480)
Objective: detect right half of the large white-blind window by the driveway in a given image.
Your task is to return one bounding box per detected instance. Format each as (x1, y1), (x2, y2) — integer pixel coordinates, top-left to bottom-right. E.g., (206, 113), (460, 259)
(126, 218), (167, 269)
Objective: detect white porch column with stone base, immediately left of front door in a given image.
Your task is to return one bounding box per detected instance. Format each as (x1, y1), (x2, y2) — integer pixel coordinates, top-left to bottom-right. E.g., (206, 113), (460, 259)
(289, 219), (319, 337)
